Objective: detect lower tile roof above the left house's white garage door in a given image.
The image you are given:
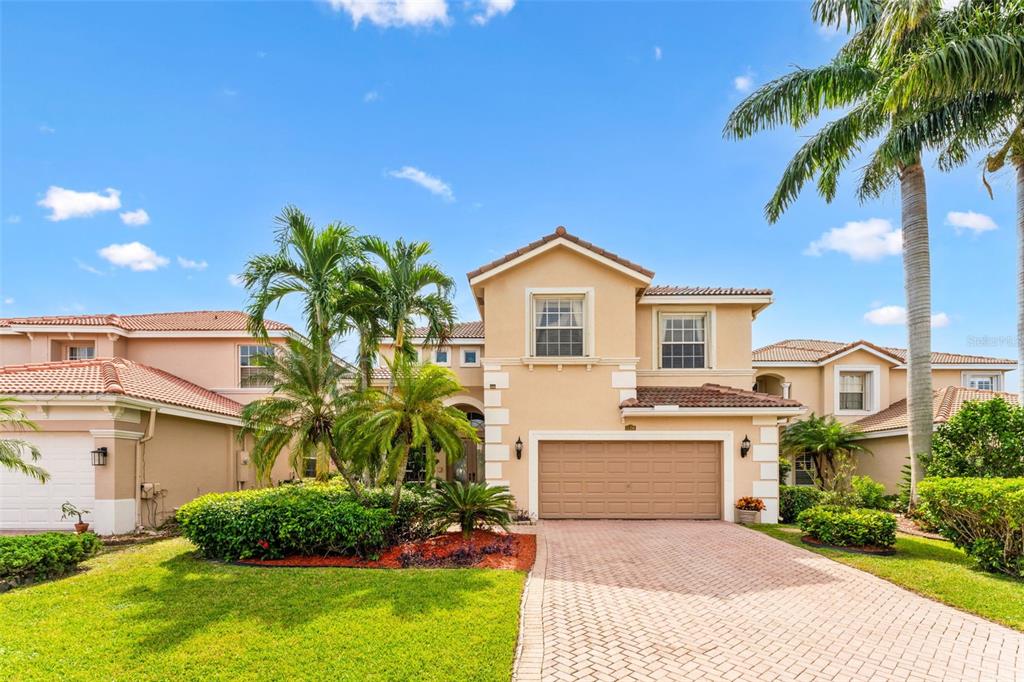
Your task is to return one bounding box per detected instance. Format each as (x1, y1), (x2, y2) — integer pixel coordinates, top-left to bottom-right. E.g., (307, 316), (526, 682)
(0, 357), (242, 417)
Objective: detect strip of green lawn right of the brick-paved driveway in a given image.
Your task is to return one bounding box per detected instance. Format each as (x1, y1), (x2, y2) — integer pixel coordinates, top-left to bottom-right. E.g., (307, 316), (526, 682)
(753, 525), (1024, 631)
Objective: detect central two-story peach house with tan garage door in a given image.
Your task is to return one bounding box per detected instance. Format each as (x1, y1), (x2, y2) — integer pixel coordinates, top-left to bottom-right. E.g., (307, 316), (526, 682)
(375, 227), (805, 522)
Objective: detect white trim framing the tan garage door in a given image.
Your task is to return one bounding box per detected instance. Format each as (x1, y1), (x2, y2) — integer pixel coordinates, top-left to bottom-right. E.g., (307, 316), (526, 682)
(526, 430), (736, 521)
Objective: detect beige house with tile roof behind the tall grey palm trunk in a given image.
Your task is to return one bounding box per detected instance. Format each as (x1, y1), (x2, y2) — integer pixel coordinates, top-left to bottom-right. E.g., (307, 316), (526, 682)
(753, 339), (1017, 492)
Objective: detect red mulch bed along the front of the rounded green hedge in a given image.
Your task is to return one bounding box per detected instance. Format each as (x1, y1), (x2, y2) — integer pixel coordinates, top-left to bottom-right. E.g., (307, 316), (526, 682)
(238, 530), (537, 570)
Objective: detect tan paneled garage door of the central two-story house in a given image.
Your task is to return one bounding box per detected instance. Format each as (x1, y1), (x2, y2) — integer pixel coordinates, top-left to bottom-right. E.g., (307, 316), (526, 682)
(540, 440), (722, 519)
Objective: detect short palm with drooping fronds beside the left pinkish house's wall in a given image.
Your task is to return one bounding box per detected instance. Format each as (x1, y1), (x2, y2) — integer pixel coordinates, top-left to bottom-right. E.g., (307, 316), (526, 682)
(239, 338), (361, 498)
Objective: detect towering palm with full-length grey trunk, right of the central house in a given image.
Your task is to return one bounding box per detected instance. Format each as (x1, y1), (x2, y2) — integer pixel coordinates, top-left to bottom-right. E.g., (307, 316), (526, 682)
(725, 0), (982, 499)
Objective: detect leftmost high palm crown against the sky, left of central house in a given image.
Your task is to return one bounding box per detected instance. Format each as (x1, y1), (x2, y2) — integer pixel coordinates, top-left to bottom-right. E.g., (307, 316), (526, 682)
(242, 206), (361, 343)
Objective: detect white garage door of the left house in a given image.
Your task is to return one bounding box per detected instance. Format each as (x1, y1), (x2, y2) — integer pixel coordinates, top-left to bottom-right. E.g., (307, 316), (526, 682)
(0, 433), (95, 530)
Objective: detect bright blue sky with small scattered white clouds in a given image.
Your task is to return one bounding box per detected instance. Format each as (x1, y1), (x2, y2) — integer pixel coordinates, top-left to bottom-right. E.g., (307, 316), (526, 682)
(0, 0), (1016, 376)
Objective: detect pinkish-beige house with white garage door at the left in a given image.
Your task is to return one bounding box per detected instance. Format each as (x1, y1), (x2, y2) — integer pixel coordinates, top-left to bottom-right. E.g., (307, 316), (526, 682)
(0, 311), (291, 534)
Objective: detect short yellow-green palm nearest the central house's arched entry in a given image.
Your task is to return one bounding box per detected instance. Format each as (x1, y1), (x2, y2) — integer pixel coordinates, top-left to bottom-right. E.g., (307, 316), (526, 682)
(341, 354), (479, 512)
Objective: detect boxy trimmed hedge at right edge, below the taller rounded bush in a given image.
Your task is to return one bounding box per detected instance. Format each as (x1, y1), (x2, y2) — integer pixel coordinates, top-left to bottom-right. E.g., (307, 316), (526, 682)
(918, 478), (1024, 578)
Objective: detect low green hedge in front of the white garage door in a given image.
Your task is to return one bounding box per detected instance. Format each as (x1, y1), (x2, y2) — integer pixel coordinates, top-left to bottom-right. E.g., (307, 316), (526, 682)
(0, 532), (100, 584)
